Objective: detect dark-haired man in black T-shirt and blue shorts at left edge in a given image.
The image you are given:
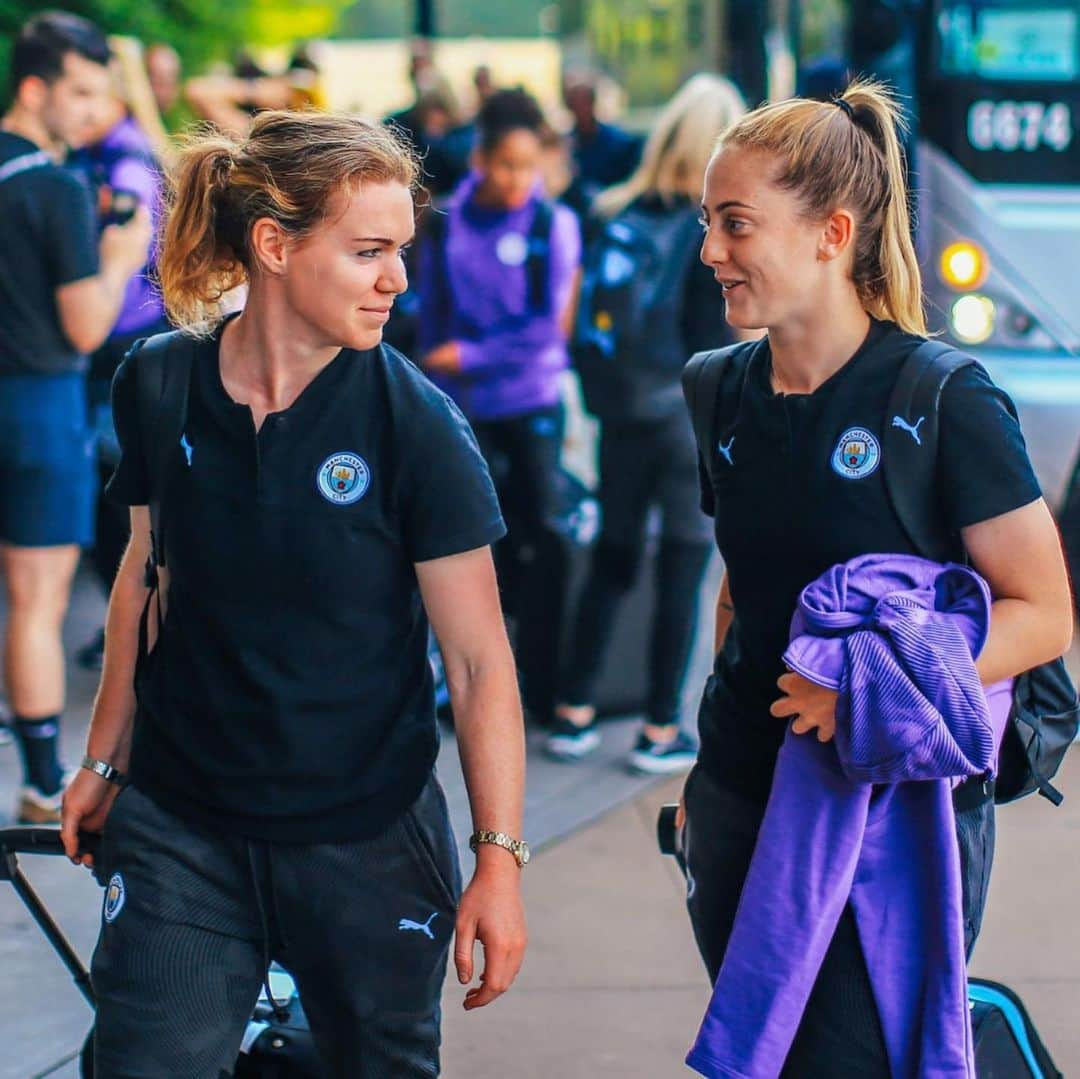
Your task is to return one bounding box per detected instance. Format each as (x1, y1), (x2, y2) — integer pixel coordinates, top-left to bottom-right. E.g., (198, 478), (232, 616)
(0, 12), (150, 823)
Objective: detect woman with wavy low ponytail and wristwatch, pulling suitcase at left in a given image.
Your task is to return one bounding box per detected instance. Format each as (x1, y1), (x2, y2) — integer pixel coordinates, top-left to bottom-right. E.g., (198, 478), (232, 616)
(62, 112), (528, 1079)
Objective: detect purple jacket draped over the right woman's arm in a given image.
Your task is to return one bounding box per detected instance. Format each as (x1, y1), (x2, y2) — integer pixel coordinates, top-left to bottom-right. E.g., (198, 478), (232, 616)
(687, 555), (1011, 1079)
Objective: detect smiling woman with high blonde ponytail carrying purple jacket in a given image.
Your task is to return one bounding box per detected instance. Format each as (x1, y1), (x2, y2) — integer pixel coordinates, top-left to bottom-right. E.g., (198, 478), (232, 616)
(683, 82), (1072, 1079)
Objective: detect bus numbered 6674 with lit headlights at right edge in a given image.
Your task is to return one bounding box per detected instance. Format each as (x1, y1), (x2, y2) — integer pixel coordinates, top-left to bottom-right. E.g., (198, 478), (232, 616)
(913, 0), (1080, 508)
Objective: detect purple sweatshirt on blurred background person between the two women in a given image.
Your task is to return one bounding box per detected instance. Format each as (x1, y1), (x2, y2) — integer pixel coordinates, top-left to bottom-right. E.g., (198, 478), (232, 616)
(417, 173), (581, 420)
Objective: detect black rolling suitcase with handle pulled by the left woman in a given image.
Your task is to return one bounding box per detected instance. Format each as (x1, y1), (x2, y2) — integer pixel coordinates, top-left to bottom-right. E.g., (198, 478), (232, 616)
(0, 827), (323, 1079)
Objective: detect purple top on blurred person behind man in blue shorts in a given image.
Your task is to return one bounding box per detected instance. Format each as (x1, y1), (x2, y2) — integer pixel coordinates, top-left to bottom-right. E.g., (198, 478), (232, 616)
(71, 117), (165, 337)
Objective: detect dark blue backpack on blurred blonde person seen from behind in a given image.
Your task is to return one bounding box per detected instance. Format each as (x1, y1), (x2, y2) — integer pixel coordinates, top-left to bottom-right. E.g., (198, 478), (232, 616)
(570, 206), (701, 420)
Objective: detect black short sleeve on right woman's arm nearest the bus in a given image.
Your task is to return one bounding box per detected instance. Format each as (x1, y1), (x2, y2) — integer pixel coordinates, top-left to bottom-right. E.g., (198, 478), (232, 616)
(939, 364), (1042, 531)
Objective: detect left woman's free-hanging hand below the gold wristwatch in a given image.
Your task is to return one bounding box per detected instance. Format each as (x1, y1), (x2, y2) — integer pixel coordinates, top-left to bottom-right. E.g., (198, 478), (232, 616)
(454, 848), (528, 1011)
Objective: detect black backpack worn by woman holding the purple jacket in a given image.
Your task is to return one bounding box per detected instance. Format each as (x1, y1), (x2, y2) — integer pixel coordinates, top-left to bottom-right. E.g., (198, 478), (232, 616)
(683, 341), (1080, 806)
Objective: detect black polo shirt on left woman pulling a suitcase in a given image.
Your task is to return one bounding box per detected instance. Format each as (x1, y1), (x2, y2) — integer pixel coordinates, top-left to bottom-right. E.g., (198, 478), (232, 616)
(109, 331), (504, 841)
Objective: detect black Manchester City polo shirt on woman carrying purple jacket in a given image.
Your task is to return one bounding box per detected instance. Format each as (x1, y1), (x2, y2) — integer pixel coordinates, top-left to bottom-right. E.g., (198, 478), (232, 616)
(701, 322), (1040, 801)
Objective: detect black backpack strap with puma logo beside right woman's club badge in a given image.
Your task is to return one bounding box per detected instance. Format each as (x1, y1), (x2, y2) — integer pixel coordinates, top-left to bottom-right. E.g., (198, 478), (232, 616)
(881, 341), (974, 562)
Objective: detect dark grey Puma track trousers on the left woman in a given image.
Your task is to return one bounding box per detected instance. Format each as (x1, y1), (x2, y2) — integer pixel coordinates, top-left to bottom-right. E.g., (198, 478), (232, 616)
(91, 775), (461, 1079)
